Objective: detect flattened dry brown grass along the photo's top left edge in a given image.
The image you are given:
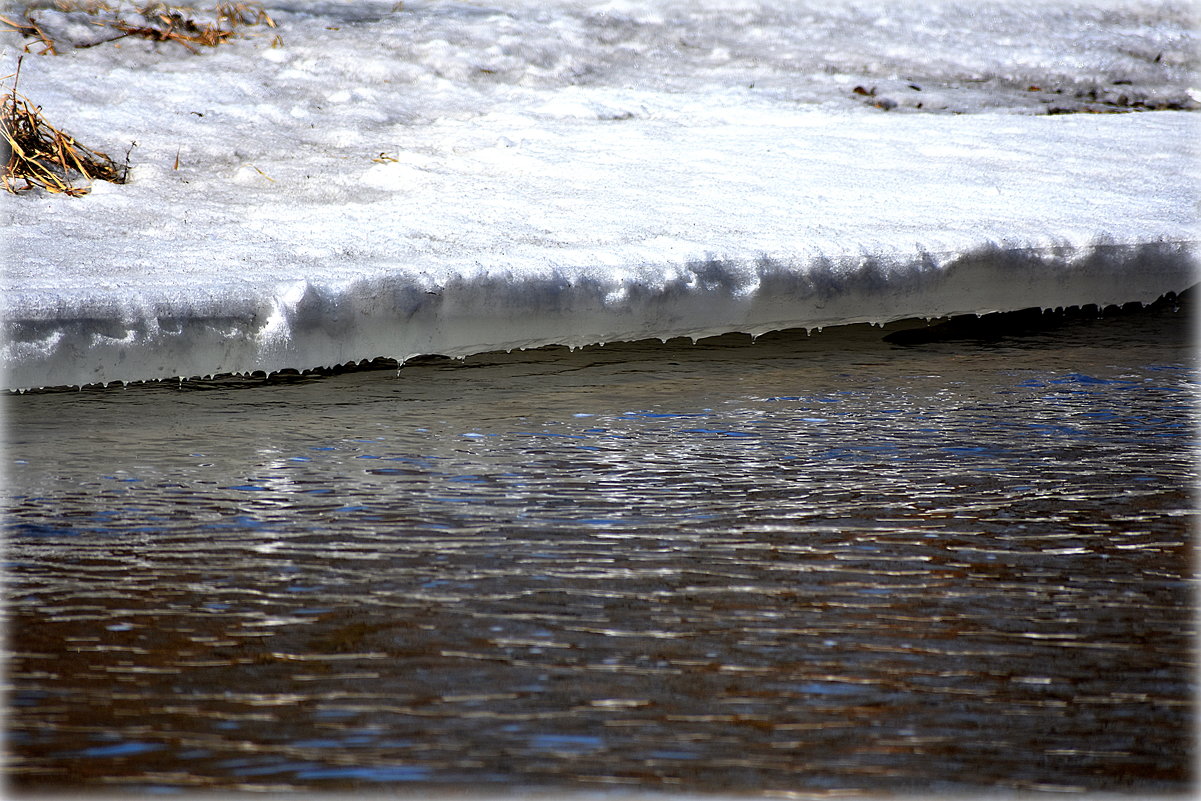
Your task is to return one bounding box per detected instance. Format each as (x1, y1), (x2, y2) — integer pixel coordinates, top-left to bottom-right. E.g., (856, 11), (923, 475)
(0, 0), (275, 55)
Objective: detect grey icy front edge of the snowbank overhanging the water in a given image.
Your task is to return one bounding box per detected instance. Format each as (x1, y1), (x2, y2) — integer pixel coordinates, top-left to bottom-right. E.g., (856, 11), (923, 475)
(0, 240), (1201, 390)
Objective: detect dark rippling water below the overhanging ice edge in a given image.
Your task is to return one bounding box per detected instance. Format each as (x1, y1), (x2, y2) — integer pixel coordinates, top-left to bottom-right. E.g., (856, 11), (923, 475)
(6, 297), (1196, 794)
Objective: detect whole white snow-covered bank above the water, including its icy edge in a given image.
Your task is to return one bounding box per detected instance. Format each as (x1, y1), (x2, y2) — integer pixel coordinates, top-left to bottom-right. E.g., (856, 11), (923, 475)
(0, 0), (1201, 388)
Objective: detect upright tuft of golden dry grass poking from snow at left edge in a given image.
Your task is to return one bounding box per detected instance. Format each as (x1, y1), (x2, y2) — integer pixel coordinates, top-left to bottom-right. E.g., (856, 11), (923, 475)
(0, 64), (129, 197)
